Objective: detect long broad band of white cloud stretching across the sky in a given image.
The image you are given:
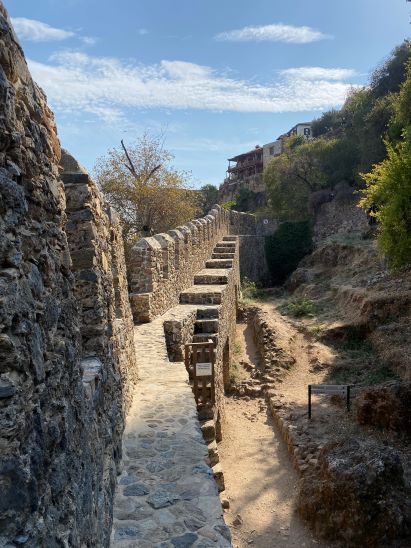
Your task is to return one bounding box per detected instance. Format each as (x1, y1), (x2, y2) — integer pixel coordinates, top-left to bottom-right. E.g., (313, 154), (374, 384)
(29, 51), (358, 122)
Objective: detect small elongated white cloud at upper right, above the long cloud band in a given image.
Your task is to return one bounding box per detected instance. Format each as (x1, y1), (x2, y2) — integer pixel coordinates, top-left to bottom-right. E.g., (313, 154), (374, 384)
(215, 23), (332, 44)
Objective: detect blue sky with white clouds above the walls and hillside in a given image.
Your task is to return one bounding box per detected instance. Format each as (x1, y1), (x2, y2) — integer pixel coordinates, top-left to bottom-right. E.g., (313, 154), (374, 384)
(4, 0), (411, 186)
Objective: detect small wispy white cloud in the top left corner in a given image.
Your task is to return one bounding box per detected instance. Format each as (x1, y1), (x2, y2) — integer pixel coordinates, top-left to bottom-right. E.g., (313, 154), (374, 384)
(11, 17), (96, 45)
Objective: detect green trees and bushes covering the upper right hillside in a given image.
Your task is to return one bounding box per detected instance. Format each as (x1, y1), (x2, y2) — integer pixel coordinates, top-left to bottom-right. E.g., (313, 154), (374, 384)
(264, 40), (411, 269)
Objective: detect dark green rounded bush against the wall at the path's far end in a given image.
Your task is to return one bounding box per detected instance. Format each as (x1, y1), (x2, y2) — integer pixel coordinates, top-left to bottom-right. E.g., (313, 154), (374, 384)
(265, 221), (312, 285)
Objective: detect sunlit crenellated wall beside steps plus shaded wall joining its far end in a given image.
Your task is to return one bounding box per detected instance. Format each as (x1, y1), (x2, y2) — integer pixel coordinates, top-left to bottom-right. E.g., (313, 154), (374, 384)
(128, 205), (276, 322)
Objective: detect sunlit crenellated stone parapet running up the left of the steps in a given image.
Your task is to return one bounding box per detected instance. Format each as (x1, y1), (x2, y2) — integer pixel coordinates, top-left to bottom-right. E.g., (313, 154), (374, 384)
(128, 206), (230, 322)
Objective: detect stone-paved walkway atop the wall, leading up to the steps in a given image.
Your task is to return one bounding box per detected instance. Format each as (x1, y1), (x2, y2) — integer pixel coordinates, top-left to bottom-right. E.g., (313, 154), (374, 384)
(111, 307), (231, 548)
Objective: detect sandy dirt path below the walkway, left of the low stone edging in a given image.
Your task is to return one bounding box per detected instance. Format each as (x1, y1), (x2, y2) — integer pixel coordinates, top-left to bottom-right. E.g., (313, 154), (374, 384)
(219, 325), (324, 548)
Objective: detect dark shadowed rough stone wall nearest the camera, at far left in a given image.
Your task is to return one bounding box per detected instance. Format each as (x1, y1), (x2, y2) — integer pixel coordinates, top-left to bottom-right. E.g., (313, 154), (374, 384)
(0, 6), (138, 547)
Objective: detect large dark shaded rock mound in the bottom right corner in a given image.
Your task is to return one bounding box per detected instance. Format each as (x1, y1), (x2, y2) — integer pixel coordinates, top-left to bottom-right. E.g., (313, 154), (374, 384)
(297, 438), (411, 548)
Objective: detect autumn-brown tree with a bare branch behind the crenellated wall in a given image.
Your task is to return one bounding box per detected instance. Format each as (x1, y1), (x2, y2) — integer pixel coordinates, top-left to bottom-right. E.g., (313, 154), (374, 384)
(94, 134), (198, 244)
